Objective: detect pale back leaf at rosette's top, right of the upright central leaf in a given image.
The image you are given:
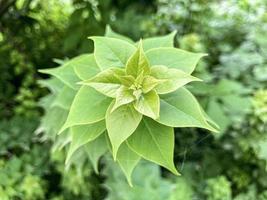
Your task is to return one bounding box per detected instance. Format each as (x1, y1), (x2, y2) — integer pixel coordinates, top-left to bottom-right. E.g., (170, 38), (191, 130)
(143, 31), (176, 51)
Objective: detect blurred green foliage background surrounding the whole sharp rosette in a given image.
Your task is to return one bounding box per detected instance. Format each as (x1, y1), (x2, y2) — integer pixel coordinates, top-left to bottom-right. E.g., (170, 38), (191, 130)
(0, 0), (267, 200)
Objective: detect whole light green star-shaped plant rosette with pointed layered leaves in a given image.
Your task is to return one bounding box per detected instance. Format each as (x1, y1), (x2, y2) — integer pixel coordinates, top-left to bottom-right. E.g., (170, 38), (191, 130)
(40, 27), (218, 185)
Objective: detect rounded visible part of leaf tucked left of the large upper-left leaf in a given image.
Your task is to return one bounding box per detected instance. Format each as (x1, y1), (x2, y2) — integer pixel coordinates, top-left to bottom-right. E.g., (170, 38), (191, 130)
(74, 54), (100, 80)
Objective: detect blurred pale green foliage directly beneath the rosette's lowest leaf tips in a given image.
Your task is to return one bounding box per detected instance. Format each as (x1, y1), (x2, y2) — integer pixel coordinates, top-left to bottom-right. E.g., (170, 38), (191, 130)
(103, 161), (193, 200)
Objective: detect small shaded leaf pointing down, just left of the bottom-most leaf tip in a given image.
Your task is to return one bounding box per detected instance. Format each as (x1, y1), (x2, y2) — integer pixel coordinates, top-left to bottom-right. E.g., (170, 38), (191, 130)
(84, 133), (108, 174)
